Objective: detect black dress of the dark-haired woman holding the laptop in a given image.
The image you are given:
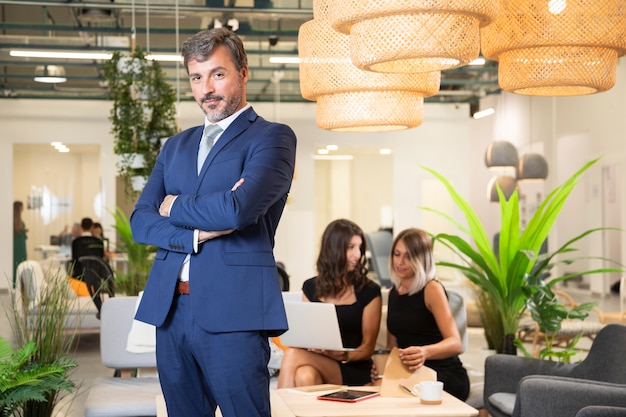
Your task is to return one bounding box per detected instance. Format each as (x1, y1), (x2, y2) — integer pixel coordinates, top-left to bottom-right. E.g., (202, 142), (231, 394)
(302, 277), (380, 385)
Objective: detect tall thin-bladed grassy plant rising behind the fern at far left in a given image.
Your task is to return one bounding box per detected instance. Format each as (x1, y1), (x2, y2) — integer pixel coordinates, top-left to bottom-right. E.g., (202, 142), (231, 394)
(9, 269), (79, 417)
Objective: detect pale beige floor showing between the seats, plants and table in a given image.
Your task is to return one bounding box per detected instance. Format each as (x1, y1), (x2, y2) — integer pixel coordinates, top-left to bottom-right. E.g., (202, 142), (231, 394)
(0, 287), (619, 417)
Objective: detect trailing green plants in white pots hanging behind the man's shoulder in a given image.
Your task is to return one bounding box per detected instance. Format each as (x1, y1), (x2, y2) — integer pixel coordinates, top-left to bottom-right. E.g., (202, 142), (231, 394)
(103, 48), (178, 198)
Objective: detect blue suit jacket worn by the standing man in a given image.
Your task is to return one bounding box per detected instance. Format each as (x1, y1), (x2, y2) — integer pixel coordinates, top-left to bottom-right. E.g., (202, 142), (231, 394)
(130, 108), (296, 336)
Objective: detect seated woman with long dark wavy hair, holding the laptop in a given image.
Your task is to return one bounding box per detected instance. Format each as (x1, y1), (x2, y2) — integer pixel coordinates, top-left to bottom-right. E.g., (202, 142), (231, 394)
(278, 219), (382, 388)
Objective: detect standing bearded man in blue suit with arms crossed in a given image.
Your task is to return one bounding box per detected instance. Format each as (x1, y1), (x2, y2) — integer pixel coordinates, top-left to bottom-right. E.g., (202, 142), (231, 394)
(130, 28), (296, 417)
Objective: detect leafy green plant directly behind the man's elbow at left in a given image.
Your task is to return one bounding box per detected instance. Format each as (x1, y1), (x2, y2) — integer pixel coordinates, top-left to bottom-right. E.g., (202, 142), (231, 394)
(113, 207), (156, 296)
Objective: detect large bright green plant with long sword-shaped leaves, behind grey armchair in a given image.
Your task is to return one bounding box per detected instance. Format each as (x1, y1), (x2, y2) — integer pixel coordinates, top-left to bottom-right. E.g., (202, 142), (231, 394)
(423, 159), (621, 353)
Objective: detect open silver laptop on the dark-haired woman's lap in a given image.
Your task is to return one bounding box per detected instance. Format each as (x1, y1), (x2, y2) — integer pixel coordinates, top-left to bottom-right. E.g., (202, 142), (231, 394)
(280, 300), (355, 351)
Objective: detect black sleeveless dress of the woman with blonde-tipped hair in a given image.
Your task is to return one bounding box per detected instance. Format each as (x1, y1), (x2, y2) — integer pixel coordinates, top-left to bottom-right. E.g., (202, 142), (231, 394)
(387, 282), (470, 401)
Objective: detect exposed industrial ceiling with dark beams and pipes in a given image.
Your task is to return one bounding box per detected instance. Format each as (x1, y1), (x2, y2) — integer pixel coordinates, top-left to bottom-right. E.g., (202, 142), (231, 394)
(0, 0), (500, 104)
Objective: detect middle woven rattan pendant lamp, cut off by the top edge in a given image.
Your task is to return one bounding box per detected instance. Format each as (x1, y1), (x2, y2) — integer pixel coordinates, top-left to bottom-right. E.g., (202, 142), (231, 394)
(328, 0), (497, 73)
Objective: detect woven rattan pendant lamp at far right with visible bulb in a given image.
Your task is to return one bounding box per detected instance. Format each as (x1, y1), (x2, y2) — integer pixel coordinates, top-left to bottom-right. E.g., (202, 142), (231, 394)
(481, 0), (626, 96)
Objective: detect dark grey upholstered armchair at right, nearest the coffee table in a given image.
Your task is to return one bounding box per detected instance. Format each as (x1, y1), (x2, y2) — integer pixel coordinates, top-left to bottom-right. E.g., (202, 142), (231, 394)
(484, 324), (626, 417)
